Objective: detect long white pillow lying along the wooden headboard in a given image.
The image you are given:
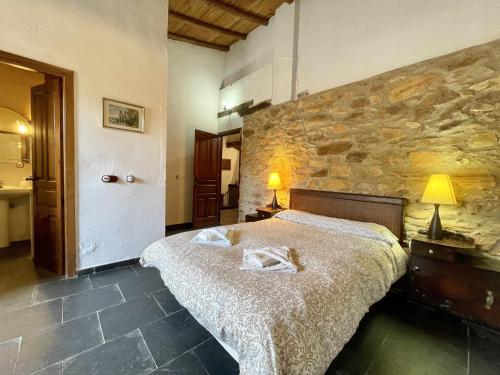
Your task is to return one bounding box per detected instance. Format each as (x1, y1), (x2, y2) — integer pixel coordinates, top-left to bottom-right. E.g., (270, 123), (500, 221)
(274, 210), (399, 246)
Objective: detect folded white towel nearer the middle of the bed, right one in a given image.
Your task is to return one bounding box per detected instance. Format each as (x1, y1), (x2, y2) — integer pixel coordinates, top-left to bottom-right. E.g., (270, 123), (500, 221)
(240, 246), (298, 272)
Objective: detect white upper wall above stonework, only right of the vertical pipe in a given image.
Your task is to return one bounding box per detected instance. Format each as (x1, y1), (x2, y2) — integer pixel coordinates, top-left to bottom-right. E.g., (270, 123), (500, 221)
(298, 0), (500, 93)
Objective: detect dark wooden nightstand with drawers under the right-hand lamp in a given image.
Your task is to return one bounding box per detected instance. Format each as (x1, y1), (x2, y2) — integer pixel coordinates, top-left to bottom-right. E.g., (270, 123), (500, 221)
(408, 236), (500, 328)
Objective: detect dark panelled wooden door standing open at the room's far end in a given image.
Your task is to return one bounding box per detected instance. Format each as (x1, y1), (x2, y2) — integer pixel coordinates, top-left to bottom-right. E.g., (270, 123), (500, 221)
(193, 130), (222, 228)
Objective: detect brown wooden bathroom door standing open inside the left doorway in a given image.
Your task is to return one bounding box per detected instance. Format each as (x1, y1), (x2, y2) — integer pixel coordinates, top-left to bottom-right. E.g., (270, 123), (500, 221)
(31, 76), (64, 275)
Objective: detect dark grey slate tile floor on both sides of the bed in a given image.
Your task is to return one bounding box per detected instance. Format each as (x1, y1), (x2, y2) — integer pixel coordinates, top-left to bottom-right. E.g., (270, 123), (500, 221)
(0, 242), (500, 375)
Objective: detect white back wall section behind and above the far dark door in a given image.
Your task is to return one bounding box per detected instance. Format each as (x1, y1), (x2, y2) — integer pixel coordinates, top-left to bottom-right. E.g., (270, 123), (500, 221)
(167, 40), (224, 225)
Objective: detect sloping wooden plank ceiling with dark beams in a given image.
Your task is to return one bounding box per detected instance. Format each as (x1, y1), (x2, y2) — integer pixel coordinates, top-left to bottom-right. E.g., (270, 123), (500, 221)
(168, 0), (293, 51)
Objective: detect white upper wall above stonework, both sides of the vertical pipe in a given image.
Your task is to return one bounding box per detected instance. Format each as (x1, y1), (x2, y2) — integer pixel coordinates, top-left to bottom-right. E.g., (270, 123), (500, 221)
(223, 0), (500, 106)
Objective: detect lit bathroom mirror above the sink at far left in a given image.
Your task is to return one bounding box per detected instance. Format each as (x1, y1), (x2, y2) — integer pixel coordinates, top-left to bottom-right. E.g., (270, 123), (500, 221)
(0, 107), (31, 164)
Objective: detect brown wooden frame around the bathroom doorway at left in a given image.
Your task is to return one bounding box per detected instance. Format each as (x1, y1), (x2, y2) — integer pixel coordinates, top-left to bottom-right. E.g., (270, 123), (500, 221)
(0, 50), (76, 277)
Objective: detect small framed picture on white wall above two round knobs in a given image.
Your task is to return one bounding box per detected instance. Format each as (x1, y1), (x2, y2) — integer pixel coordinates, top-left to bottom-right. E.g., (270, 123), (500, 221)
(102, 98), (145, 133)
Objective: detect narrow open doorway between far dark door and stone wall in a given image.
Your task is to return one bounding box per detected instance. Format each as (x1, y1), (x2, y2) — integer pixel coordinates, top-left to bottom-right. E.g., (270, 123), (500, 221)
(220, 129), (241, 225)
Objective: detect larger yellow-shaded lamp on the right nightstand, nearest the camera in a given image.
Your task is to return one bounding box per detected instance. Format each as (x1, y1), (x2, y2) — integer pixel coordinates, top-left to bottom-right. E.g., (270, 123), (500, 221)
(421, 174), (457, 240)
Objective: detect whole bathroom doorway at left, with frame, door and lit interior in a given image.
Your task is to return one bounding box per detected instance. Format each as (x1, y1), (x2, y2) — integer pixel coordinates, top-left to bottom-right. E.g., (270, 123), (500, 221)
(0, 51), (76, 302)
